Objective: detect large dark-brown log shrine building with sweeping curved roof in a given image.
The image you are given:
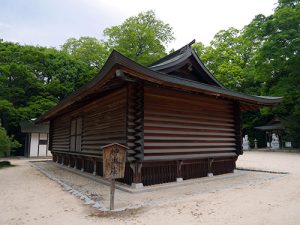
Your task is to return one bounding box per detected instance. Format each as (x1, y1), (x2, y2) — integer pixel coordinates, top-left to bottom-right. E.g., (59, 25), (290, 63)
(38, 42), (281, 185)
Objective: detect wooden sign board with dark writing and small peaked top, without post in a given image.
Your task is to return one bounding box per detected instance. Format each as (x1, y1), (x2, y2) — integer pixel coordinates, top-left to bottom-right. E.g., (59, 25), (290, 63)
(102, 143), (128, 179)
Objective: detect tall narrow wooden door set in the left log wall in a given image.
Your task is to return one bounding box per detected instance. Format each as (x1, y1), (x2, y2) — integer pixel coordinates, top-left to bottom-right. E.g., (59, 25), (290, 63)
(70, 117), (82, 152)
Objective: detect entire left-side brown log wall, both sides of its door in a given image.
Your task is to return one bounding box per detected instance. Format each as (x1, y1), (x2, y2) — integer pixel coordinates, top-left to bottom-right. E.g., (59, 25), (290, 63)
(50, 88), (127, 156)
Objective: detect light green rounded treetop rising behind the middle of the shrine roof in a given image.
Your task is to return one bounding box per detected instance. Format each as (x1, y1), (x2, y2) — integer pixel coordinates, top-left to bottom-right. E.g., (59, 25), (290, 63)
(104, 11), (174, 65)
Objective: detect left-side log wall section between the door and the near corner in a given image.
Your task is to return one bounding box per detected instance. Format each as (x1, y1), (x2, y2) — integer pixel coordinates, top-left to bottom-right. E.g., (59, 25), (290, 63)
(81, 88), (127, 155)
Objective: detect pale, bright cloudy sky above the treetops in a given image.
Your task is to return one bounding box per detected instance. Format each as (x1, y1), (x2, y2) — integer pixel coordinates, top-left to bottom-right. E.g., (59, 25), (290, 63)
(0, 0), (277, 49)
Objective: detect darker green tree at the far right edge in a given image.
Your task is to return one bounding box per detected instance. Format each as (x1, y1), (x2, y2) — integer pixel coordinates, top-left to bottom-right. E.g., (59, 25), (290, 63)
(254, 0), (300, 141)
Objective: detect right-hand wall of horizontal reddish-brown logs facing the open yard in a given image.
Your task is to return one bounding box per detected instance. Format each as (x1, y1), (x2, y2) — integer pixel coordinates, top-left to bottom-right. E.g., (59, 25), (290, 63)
(144, 86), (236, 161)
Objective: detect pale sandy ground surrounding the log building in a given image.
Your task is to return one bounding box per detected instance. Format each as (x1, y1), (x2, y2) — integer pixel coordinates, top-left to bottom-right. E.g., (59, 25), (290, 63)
(0, 152), (300, 225)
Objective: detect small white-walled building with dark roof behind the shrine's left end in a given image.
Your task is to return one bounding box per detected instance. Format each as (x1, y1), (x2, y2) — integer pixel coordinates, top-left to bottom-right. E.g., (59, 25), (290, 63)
(20, 121), (52, 157)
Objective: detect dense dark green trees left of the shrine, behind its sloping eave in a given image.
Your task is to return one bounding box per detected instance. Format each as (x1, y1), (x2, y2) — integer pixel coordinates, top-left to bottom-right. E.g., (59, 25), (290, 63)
(0, 41), (95, 144)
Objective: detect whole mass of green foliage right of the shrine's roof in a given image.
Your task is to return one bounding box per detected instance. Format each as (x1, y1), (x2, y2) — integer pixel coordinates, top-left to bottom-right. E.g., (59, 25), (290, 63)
(194, 0), (300, 140)
